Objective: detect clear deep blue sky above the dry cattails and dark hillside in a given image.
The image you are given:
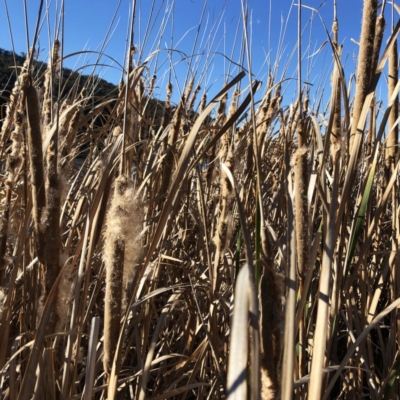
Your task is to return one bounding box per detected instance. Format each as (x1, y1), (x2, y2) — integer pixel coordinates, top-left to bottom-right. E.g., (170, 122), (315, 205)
(0, 0), (397, 108)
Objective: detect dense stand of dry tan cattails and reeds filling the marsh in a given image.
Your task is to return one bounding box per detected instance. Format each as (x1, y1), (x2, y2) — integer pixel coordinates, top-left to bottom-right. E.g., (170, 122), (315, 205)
(0, 0), (400, 400)
